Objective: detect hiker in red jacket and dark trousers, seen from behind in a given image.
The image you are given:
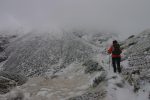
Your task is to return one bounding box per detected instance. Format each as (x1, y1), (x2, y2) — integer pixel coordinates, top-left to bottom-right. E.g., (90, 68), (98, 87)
(108, 40), (122, 73)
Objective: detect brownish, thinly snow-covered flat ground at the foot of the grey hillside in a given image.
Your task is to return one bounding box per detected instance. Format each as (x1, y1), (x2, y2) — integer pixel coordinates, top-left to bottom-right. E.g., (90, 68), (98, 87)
(14, 64), (97, 100)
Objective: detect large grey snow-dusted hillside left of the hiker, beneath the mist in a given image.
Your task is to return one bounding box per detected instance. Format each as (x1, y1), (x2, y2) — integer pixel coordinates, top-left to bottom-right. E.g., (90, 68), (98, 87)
(3, 34), (94, 76)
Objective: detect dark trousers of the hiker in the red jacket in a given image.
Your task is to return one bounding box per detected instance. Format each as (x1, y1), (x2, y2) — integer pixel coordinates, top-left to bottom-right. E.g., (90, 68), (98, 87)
(112, 57), (121, 73)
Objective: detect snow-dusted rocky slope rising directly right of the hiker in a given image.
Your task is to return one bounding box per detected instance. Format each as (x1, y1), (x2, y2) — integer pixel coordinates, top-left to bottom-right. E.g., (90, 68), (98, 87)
(113, 30), (150, 100)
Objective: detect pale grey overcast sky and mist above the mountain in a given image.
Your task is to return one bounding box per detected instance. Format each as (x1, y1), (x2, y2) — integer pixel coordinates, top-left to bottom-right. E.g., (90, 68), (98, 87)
(0, 0), (150, 37)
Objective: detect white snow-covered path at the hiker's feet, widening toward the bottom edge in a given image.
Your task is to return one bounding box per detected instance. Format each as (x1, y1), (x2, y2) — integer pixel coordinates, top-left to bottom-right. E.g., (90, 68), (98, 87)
(97, 54), (148, 100)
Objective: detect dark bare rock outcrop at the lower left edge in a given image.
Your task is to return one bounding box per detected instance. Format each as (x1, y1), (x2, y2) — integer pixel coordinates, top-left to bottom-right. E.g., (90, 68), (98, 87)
(0, 71), (27, 94)
